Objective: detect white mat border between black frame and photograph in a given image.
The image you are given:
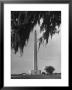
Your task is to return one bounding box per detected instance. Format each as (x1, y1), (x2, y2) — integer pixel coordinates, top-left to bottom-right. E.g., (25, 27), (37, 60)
(4, 4), (69, 87)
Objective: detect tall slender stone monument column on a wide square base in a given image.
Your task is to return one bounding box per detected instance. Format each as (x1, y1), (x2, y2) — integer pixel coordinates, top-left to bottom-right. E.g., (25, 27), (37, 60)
(31, 31), (41, 75)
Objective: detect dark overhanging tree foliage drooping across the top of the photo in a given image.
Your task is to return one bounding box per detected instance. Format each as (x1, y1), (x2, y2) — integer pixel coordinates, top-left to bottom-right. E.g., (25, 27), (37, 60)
(11, 11), (61, 53)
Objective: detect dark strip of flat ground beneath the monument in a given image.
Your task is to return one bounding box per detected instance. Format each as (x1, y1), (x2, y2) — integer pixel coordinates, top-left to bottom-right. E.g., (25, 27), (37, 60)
(11, 74), (61, 79)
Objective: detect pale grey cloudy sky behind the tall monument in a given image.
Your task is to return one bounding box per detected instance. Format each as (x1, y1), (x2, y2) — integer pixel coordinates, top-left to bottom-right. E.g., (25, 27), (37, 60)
(11, 21), (61, 74)
